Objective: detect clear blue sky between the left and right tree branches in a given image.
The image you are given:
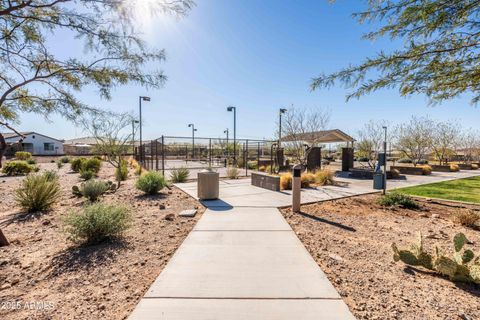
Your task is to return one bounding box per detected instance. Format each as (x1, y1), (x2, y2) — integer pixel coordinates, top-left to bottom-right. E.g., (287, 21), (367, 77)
(19, 0), (480, 139)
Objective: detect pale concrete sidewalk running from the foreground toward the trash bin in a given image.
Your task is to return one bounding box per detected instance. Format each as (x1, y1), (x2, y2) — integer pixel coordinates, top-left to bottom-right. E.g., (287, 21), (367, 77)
(130, 206), (355, 320)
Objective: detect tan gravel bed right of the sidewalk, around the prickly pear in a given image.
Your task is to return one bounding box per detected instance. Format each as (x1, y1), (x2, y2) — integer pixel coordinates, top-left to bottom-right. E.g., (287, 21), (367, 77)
(282, 195), (480, 320)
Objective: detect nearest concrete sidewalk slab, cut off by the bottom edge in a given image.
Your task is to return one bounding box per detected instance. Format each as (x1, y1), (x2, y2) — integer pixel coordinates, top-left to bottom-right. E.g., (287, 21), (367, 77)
(130, 299), (355, 320)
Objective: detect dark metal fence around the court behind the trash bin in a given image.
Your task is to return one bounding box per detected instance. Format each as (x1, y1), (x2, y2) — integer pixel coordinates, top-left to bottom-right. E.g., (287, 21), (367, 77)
(134, 136), (275, 179)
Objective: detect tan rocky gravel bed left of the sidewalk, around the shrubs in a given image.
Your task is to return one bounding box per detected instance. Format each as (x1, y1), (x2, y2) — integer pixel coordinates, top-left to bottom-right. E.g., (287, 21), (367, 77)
(0, 163), (204, 319)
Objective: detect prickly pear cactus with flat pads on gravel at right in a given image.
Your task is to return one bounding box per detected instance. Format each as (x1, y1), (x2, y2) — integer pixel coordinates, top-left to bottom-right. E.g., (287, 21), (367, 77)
(392, 233), (480, 284)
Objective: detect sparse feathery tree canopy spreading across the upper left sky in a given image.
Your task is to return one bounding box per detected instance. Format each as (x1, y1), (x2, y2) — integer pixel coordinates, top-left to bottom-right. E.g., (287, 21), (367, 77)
(0, 0), (193, 246)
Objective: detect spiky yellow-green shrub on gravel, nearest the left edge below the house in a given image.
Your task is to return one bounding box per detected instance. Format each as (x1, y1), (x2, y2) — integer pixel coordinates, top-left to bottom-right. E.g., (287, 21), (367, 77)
(15, 173), (61, 212)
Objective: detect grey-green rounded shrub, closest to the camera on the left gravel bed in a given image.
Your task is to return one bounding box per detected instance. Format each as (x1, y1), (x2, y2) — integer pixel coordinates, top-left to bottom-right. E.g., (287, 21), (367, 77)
(65, 202), (132, 245)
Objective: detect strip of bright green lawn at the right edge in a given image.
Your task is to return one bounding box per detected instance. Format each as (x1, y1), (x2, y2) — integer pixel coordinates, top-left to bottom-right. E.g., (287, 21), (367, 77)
(397, 177), (480, 203)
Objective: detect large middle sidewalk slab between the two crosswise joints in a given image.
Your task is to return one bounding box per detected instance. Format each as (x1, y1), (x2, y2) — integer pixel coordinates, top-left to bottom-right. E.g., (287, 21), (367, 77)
(145, 231), (340, 299)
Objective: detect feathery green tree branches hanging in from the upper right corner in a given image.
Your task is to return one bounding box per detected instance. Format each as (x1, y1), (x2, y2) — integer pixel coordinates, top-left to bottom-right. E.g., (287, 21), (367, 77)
(311, 0), (480, 104)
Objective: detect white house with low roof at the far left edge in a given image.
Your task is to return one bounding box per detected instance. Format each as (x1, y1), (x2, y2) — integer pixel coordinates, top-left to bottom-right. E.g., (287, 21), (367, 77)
(2, 131), (64, 156)
